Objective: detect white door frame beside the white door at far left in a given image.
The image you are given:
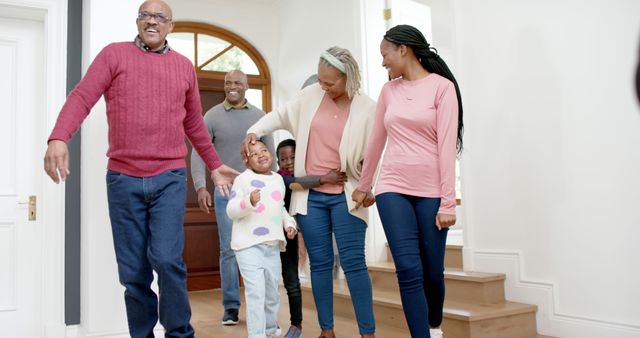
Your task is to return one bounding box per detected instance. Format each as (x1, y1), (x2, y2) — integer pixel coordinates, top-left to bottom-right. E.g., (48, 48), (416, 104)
(0, 0), (67, 338)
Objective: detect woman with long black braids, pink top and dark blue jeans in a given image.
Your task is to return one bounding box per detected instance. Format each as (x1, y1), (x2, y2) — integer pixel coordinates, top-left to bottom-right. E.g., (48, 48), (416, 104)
(352, 25), (462, 338)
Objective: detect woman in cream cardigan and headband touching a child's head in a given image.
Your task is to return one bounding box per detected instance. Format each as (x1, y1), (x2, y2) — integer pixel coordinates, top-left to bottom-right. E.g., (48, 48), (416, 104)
(243, 47), (376, 338)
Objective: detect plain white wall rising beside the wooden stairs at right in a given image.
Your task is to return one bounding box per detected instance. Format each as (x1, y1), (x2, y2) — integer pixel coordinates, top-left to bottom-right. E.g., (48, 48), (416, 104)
(454, 0), (640, 338)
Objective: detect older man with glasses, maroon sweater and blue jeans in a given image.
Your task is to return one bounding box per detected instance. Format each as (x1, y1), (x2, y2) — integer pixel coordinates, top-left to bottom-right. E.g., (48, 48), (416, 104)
(44, 0), (238, 338)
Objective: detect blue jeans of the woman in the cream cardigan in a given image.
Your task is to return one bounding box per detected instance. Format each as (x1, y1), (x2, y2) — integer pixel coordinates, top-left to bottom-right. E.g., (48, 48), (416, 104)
(296, 190), (376, 335)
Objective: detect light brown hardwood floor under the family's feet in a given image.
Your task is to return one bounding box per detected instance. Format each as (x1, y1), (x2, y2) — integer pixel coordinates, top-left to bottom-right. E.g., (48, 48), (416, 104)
(189, 287), (409, 338)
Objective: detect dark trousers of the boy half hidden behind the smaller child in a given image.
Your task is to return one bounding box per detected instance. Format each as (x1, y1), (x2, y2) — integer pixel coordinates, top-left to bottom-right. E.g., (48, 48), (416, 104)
(280, 235), (302, 326)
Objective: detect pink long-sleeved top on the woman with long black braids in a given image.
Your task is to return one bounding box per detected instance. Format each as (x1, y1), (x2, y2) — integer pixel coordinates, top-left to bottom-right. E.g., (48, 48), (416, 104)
(358, 73), (458, 215)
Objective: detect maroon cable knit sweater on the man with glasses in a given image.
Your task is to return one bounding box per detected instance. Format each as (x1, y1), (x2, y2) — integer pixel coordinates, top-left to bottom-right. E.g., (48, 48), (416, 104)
(49, 42), (222, 177)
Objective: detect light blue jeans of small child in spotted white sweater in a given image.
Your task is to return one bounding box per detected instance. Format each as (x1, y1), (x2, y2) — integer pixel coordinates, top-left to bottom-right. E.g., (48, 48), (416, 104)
(236, 244), (281, 338)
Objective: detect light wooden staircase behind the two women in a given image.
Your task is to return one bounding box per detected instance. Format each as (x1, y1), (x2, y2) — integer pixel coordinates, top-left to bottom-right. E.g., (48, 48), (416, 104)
(302, 245), (550, 338)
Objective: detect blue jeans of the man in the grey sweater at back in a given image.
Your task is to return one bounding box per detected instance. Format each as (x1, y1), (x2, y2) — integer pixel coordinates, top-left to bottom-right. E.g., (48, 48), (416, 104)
(213, 188), (240, 310)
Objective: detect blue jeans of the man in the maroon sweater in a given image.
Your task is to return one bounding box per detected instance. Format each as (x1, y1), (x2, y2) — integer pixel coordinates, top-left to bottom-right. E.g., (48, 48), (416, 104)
(106, 168), (194, 338)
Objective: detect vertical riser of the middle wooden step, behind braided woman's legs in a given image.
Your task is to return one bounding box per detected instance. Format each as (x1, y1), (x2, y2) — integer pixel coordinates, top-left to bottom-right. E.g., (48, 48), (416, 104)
(369, 270), (505, 305)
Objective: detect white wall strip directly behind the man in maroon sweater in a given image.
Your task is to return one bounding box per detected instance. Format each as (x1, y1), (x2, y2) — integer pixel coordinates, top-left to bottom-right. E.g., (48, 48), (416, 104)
(79, 0), (144, 337)
